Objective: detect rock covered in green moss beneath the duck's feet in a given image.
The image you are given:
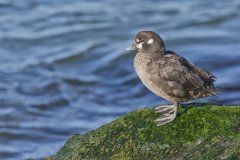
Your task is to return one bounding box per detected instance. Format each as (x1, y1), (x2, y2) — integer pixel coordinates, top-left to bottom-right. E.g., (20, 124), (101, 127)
(53, 105), (240, 160)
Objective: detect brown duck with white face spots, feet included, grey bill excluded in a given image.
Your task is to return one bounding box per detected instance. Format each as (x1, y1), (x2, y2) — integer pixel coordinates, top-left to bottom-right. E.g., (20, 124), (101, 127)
(127, 31), (217, 125)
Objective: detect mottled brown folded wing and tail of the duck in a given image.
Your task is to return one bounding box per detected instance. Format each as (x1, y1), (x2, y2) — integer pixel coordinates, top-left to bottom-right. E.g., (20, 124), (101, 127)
(150, 52), (216, 100)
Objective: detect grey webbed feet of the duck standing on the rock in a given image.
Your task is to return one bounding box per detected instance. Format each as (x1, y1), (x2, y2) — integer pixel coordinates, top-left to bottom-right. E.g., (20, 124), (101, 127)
(155, 102), (181, 126)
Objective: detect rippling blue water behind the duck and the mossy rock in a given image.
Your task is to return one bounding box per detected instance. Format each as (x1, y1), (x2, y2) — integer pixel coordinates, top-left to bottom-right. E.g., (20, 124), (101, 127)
(0, 0), (240, 160)
